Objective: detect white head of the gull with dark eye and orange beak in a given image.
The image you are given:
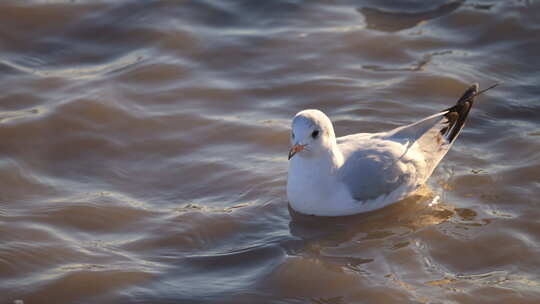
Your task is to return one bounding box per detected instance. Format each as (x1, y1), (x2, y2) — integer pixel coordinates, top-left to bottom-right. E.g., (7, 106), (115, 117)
(289, 110), (336, 159)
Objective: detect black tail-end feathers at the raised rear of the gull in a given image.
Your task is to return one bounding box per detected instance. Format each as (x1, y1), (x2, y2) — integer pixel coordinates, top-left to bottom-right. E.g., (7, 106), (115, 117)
(441, 83), (480, 144)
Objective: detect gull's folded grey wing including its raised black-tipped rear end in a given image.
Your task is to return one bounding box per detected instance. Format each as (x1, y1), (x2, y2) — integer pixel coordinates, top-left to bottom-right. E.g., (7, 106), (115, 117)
(337, 84), (478, 201)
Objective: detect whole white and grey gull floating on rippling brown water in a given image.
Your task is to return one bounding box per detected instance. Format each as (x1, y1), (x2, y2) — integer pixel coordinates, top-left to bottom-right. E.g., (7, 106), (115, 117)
(287, 83), (497, 216)
